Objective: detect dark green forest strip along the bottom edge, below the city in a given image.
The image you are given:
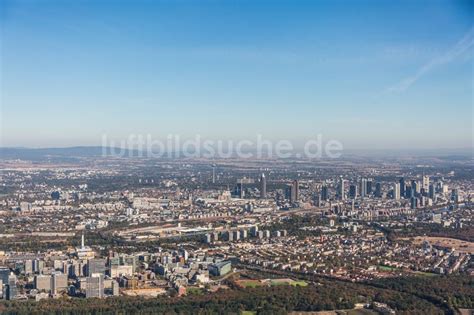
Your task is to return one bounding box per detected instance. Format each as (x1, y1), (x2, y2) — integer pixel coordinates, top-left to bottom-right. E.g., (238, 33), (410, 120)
(0, 276), (474, 314)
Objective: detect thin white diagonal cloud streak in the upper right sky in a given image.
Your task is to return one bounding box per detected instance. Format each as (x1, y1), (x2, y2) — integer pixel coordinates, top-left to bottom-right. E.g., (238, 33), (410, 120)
(385, 27), (474, 93)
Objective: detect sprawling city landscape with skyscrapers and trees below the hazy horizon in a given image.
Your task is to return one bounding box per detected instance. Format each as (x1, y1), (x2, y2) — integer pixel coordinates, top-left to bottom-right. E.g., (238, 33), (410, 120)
(0, 149), (474, 314)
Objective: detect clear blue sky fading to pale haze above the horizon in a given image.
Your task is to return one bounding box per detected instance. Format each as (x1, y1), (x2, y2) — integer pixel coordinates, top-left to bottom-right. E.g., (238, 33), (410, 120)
(0, 0), (474, 149)
